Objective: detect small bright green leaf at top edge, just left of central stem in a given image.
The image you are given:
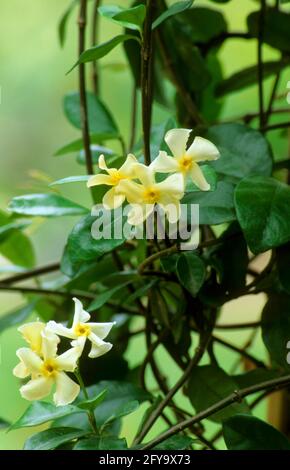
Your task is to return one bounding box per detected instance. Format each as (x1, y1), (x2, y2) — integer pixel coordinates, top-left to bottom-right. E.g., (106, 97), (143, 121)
(98, 5), (146, 31)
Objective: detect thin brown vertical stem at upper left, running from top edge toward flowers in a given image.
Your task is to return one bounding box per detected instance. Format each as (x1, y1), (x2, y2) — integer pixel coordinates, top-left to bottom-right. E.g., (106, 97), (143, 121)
(78, 0), (94, 175)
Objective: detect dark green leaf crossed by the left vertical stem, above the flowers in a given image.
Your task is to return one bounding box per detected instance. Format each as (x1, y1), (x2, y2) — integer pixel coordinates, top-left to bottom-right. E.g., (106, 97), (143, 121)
(63, 92), (119, 138)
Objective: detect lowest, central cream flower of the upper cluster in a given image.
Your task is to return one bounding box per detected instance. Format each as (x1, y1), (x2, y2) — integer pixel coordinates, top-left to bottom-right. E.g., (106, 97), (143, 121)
(119, 163), (184, 225)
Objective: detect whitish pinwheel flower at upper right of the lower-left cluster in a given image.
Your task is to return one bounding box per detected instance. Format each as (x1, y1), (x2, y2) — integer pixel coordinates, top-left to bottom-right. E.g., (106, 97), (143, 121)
(47, 298), (115, 358)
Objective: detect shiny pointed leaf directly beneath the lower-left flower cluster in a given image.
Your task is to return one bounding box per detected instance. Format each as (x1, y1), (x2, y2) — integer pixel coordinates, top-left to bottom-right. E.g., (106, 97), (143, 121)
(10, 401), (80, 429)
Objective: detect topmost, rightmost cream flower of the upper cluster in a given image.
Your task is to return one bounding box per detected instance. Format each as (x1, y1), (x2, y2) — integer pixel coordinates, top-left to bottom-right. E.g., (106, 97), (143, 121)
(152, 129), (220, 191)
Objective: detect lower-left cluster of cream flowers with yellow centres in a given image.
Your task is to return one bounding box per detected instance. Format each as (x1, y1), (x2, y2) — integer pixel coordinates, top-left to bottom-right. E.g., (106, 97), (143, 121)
(13, 298), (114, 406)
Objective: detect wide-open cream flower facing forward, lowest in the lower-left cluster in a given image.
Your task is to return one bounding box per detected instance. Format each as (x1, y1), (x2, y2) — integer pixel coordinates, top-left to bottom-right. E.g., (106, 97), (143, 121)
(13, 329), (80, 406)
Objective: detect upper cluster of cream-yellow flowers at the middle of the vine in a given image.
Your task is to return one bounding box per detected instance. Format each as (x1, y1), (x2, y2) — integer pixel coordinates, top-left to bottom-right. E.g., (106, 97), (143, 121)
(88, 129), (219, 225)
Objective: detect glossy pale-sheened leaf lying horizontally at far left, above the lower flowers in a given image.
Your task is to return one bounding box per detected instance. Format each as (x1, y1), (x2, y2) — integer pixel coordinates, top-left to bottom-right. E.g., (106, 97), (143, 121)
(8, 193), (88, 217)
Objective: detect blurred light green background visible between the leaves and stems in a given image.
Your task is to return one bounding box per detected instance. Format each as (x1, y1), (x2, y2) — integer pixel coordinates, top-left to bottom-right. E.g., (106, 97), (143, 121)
(0, 0), (288, 449)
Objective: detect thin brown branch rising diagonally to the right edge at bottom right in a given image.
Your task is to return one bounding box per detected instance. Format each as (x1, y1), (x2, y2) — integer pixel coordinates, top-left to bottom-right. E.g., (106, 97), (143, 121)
(142, 375), (290, 450)
